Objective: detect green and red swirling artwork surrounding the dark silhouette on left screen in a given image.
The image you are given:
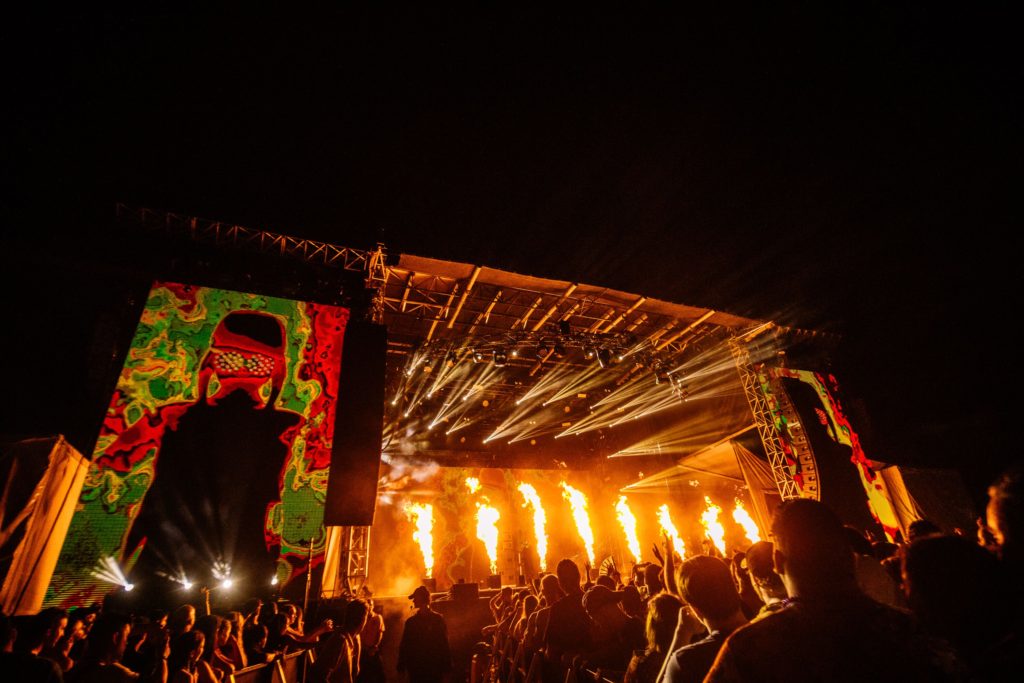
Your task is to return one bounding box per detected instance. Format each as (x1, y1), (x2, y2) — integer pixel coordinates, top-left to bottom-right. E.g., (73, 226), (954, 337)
(46, 282), (349, 606)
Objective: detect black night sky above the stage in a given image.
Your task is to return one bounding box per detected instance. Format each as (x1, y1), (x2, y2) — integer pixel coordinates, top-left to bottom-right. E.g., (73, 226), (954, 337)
(2, 2), (1024, 497)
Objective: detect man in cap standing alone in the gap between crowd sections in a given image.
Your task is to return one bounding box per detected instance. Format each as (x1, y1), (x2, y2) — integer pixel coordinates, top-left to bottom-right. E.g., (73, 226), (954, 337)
(397, 586), (452, 683)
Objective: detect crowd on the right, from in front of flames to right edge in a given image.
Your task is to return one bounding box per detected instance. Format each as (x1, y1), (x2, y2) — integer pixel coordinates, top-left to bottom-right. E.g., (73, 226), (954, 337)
(481, 465), (1024, 683)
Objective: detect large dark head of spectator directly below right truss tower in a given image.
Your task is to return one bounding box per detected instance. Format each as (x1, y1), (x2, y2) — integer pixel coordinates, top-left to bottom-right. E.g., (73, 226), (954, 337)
(772, 498), (857, 597)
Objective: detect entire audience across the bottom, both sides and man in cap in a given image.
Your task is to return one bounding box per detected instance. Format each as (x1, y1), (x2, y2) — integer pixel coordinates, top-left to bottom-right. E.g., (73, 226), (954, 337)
(0, 466), (1024, 683)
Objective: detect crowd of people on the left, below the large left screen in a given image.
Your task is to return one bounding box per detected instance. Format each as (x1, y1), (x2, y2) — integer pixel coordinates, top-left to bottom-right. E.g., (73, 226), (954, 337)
(0, 591), (385, 683)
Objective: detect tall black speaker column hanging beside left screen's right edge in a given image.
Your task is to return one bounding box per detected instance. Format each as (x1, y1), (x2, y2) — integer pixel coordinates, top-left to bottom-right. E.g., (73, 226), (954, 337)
(324, 321), (387, 526)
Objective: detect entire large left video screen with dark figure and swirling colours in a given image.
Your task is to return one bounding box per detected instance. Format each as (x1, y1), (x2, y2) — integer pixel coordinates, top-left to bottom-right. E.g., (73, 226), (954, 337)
(46, 282), (349, 606)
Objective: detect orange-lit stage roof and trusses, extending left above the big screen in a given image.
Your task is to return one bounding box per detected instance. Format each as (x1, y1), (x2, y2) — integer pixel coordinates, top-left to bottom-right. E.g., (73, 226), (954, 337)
(118, 205), (827, 471)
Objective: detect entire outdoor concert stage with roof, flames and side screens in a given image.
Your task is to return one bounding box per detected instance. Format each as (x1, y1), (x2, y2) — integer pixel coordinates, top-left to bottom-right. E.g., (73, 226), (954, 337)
(4, 207), (974, 610)
